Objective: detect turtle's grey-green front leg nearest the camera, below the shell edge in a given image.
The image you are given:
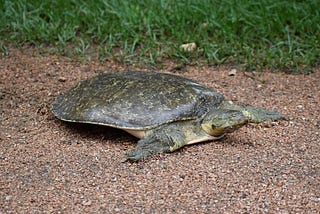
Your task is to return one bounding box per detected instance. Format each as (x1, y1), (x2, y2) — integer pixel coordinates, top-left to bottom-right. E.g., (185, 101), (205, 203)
(127, 124), (186, 161)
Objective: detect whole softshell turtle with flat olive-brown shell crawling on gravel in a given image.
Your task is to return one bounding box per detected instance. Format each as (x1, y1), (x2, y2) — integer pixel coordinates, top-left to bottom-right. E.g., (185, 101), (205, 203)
(51, 71), (284, 161)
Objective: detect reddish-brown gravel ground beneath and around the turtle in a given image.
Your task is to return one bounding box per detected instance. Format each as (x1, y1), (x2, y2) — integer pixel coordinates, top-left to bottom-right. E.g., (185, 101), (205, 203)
(0, 48), (320, 213)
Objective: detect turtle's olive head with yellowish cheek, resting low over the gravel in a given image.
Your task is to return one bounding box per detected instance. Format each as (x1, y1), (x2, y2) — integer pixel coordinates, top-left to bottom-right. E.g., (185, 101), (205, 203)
(201, 109), (248, 137)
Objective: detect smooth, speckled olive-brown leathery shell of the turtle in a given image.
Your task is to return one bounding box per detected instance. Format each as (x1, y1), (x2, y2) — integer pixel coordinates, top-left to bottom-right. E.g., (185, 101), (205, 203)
(51, 71), (224, 130)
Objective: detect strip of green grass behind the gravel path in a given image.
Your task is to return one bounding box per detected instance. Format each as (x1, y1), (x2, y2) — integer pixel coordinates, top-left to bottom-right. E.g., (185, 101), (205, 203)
(0, 0), (320, 72)
